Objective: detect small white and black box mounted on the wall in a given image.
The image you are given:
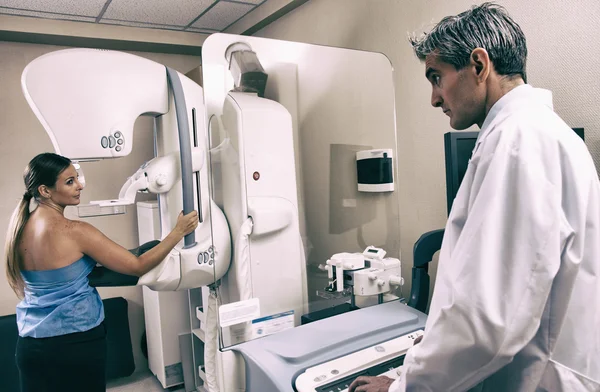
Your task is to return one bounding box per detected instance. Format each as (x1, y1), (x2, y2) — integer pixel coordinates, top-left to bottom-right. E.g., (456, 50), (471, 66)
(356, 149), (394, 192)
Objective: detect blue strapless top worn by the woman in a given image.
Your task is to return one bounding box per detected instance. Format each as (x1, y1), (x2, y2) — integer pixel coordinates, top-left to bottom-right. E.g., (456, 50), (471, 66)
(17, 255), (104, 338)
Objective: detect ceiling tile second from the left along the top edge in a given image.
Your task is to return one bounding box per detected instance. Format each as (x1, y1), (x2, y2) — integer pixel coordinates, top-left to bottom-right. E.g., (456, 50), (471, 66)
(103, 0), (215, 26)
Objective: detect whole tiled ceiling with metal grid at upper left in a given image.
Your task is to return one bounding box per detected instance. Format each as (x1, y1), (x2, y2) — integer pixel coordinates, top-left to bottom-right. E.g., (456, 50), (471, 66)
(0, 0), (266, 34)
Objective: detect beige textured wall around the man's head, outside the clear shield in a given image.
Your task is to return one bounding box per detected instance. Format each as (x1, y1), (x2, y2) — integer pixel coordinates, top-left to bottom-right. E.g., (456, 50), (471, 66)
(255, 0), (600, 300)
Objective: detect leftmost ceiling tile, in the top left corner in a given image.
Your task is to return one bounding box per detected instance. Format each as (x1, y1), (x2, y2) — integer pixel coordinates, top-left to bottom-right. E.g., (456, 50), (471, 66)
(0, 0), (106, 18)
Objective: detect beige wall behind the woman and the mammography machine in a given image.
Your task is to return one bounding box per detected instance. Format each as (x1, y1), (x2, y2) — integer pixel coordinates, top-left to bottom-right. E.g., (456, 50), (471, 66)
(0, 41), (200, 370)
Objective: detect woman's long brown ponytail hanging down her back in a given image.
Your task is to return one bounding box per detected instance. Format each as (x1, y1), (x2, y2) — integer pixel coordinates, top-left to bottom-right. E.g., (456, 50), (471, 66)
(4, 192), (33, 298)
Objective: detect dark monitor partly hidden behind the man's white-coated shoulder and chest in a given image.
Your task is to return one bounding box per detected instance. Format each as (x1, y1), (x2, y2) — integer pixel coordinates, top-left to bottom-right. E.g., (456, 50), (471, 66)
(444, 128), (585, 215)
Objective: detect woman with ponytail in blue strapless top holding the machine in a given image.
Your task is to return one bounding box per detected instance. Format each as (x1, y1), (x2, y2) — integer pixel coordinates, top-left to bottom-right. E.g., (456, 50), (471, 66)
(5, 153), (198, 392)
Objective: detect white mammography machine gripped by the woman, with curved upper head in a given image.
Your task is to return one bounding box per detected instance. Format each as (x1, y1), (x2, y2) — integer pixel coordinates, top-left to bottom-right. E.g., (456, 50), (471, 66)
(21, 49), (231, 290)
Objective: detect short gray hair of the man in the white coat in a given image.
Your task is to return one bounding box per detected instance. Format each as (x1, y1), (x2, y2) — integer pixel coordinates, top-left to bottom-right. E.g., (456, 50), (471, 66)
(410, 3), (527, 83)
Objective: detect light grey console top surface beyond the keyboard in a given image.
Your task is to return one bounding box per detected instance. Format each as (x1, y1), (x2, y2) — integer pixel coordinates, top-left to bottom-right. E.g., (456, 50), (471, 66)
(230, 301), (427, 392)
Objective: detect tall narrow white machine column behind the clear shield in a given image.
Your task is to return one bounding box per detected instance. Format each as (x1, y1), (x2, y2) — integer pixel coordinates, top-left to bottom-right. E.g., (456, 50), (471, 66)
(221, 93), (306, 343)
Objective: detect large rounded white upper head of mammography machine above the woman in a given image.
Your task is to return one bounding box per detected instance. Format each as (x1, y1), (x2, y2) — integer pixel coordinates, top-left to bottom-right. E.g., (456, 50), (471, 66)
(21, 49), (169, 160)
